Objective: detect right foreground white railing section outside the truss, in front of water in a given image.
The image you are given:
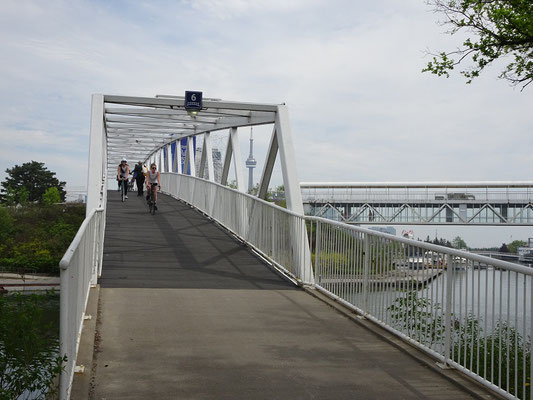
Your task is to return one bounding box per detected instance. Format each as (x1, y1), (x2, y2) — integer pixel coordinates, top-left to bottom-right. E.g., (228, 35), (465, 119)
(308, 217), (533, 399)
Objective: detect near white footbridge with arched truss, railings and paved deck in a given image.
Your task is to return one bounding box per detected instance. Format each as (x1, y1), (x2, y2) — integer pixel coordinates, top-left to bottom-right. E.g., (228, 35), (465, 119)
(60, 95), (533, 399)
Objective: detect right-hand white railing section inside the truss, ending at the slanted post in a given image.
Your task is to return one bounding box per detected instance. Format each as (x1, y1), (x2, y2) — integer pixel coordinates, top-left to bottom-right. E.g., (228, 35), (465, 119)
(161, 173), (313, 283)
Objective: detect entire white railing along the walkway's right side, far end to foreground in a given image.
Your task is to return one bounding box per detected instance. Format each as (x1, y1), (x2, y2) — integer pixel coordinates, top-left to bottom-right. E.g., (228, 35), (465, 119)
(161, 173), (533, 399)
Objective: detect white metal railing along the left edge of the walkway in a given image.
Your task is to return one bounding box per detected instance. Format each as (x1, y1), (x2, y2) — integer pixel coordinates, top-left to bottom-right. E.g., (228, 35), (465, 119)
(59, 208), (105, 399)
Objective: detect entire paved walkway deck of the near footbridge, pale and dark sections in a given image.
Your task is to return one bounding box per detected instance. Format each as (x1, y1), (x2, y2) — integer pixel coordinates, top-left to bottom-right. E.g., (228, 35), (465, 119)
(91, 192), (491, 400)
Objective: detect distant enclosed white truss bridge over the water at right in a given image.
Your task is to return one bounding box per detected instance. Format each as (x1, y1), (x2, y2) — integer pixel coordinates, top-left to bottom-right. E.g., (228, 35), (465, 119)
(300, 181), (533, 226)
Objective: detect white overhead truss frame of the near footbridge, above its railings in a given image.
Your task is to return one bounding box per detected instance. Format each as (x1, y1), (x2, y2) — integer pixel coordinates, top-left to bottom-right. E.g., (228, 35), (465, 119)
(87, 94), (303, 214)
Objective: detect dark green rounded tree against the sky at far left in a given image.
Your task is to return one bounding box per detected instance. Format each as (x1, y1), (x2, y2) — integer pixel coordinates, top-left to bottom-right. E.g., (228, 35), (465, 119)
(0, 161), (66, 204)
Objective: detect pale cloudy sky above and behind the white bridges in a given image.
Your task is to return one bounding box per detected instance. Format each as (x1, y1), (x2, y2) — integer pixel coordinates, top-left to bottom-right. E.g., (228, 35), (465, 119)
(0, 0), (533, 246)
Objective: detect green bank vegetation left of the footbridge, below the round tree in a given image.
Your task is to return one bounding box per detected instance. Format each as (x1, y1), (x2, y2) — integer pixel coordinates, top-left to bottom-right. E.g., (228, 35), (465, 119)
(0, 203), (85, 399)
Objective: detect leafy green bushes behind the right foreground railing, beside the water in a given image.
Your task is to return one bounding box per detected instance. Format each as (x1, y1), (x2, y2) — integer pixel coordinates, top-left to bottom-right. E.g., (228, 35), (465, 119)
(388, 290), (531, 399)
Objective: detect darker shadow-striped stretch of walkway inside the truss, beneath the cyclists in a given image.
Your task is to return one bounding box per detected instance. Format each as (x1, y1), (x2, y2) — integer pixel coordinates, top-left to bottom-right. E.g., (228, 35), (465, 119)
(100, 192), (295, 290)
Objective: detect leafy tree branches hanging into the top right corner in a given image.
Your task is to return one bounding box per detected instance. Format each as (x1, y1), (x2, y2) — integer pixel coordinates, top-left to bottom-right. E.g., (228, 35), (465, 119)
(422, 0), (533, 90)
